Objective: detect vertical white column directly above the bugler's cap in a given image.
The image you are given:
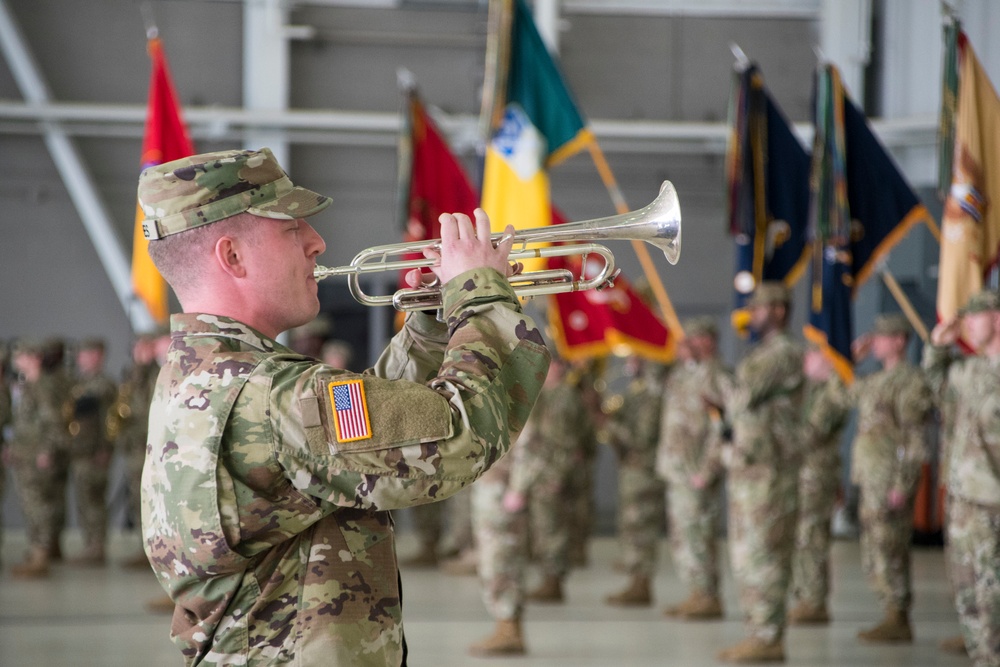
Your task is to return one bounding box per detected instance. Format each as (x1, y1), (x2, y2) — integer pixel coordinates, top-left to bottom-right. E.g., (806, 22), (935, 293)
(243, 0), (291, 166)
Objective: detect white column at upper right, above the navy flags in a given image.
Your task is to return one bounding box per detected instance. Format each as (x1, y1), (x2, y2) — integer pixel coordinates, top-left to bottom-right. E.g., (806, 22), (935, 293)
(819, 0), (872, 101)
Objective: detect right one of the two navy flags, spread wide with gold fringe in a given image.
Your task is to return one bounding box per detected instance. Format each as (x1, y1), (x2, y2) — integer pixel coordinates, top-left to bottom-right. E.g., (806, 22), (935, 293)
(805, 65), (934, 381)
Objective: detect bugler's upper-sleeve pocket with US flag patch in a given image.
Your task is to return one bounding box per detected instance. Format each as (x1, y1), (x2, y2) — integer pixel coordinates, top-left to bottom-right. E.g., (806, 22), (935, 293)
(316, 375), (452, 454)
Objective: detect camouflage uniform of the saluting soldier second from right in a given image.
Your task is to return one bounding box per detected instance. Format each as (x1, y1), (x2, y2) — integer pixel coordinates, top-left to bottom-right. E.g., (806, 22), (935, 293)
(851, 361), (932, 610)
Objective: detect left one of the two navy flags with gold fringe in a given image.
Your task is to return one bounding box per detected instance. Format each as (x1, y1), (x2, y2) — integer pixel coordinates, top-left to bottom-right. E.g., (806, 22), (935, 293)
(726, 63), (809, 333)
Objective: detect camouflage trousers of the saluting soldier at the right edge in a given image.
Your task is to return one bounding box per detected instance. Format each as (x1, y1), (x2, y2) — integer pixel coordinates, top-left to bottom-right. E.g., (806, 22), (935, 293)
(947, 495), (1000, 667)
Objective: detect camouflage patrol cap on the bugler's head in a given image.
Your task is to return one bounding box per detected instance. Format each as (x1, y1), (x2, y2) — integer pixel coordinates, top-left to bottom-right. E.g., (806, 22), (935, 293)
(138, 148), (331, 240)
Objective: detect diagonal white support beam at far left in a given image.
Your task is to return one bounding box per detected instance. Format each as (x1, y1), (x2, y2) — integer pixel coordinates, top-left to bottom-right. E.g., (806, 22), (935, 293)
(0, 0), (155, 332)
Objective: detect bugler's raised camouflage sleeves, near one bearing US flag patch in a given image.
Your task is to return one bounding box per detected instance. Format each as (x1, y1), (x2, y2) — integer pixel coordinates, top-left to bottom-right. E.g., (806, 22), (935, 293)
(266, 269), (549, 510)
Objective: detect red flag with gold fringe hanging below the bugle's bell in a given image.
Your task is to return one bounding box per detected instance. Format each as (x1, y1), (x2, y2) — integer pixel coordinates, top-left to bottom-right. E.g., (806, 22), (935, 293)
(549, 208), (676, 362)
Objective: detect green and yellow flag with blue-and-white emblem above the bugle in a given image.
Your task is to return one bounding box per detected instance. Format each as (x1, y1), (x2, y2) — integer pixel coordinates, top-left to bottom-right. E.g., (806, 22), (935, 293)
(482, 0), (594, 253)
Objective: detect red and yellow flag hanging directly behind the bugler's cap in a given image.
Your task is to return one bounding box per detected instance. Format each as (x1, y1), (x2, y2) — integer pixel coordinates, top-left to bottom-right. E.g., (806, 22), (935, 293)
(132, 37), (194, 324)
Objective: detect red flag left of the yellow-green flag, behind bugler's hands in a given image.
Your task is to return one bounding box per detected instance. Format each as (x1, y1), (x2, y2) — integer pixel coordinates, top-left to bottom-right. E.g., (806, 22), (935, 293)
(400, 92), (479, 281)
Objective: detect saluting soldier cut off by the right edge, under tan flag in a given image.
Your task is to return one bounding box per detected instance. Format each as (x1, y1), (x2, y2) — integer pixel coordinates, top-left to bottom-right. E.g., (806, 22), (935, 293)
(923, 290), (1000, 667)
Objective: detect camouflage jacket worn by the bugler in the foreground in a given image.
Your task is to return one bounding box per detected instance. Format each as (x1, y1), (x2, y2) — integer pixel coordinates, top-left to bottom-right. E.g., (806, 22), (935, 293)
(142, 280), (547, 665)
